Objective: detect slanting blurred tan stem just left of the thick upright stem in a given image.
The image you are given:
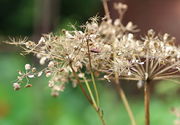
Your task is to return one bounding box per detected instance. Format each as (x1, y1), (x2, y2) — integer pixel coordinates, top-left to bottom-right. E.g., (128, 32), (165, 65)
(115, 73), (136, 125)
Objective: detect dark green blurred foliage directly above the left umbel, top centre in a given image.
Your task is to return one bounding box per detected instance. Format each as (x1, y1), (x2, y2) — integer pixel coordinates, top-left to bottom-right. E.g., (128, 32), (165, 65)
(56, 0), (101, 31)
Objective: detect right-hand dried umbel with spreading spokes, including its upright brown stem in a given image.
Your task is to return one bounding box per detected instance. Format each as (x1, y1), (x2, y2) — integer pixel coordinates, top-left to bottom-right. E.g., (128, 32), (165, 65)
(109, 30), (180, 125)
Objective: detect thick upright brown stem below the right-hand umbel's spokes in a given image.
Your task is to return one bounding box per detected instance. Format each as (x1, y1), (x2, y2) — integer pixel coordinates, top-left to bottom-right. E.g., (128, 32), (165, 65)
(144, 81), (150, 125)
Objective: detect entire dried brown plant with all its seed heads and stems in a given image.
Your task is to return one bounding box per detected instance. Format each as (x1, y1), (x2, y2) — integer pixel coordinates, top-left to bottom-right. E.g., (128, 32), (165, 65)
(5, 1), (180, 125)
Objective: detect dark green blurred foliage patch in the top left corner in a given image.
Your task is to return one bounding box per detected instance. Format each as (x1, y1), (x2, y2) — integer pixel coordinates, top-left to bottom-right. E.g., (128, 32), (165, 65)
(0, 0), (33, 36)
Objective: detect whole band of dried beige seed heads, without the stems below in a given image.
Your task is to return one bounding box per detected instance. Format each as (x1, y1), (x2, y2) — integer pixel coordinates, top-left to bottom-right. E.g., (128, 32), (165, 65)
(8, 3), (180, 95)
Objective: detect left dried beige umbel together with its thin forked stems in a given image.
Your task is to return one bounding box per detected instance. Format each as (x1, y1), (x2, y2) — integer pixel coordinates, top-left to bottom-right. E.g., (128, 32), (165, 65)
(5, 1), (137, 125)
